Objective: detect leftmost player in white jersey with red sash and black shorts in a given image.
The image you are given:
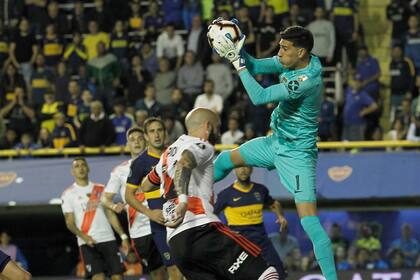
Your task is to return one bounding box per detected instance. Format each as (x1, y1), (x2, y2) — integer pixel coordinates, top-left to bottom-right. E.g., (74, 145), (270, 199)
(61, 158), (126, 280)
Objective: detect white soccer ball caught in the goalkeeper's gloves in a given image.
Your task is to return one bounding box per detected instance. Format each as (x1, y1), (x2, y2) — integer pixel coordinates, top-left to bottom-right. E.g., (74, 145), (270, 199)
(207, 18), (242, 48)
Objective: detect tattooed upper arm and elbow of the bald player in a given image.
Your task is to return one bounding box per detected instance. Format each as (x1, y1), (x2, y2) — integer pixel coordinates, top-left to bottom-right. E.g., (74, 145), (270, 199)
(174, 150), (197, 195)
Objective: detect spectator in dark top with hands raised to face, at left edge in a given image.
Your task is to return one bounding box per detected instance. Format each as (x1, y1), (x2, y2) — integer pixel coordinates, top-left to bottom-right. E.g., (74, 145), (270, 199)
(0, 87), (36, 135)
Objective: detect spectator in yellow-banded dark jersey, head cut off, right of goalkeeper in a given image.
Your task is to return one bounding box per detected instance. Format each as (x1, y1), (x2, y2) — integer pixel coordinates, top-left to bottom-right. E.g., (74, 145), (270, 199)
(330, 0), (359, 67)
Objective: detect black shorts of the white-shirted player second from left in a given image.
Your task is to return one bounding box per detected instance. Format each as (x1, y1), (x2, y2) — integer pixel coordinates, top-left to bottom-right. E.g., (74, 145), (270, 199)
(131, 234), (163, 272)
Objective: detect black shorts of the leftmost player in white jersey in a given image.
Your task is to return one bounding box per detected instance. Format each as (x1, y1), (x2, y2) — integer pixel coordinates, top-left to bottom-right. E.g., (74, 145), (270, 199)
(80, 241), (125, 278)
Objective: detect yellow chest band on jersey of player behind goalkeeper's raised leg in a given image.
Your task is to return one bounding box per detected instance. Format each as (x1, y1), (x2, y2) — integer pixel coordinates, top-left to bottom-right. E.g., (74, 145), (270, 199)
(224, 204), (263, 226)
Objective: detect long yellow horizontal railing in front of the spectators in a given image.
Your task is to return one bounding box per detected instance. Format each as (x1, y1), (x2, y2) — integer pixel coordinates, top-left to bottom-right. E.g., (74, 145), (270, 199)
(0, 141), (420, 158)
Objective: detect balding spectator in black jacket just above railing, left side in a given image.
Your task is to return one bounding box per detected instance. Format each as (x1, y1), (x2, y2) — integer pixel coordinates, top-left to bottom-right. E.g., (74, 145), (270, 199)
(80, 101), (115, 147)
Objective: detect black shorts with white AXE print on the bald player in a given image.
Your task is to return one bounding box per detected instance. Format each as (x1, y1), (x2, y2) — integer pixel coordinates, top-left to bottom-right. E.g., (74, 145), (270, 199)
(169, 223), (269, 280)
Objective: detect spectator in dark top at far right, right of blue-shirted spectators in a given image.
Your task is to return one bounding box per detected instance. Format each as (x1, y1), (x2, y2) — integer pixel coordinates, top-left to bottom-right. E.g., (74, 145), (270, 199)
(389, 45), (415, 119)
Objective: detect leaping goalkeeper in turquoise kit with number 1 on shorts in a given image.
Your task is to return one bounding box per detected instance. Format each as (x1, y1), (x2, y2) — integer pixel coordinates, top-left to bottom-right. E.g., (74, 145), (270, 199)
(212, 22), (337, 280)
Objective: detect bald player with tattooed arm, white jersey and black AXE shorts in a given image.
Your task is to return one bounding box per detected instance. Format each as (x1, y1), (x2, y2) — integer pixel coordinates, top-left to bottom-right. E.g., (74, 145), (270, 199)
(142, 108), (279, 280)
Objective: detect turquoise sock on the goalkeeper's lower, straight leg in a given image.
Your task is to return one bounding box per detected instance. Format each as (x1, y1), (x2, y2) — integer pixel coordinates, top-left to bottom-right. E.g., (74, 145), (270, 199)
(300, 216), (337, 280)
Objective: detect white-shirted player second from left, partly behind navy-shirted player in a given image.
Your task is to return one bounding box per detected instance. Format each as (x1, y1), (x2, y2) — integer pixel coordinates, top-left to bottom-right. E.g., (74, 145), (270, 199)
(102, 127), (166, 280)
